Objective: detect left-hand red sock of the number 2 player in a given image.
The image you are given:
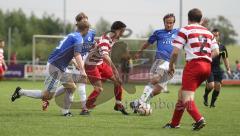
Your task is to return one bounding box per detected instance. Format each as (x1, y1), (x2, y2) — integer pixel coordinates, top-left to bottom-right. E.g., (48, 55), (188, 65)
(171, 101), (185, 126)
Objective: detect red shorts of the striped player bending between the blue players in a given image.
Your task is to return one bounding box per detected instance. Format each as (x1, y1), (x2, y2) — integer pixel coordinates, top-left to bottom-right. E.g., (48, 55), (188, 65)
(85, 62), (113, 83)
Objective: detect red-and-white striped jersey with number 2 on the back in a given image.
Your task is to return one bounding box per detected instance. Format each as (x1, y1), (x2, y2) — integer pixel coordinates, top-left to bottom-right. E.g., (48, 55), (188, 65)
(173, 24), (218, 61)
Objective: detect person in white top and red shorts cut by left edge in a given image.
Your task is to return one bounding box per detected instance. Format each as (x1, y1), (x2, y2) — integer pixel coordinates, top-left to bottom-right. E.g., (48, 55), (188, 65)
(0, 39), (7, 80)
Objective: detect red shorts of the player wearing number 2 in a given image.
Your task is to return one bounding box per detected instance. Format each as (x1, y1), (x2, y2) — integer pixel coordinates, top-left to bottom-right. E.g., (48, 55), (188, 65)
(182, 59), (211, 91)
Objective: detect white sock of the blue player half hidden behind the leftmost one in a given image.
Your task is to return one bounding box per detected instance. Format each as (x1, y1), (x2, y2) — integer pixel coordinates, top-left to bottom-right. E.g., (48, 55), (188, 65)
(77, 83), (87, 109)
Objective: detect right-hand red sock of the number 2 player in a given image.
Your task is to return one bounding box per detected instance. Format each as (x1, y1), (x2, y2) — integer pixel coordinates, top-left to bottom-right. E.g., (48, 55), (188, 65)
(185, 101), (202, 122)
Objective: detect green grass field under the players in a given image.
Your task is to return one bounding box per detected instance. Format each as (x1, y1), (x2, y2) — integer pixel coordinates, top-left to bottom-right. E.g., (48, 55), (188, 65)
(0, 81), (240, 136)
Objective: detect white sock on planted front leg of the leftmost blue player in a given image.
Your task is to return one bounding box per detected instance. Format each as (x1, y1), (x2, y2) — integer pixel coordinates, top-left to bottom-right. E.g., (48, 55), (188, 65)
(62, 90), (73, 114)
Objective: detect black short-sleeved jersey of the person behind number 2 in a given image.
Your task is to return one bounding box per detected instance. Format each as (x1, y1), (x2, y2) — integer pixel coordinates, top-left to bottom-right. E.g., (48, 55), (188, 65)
(212, 44), (228, 71)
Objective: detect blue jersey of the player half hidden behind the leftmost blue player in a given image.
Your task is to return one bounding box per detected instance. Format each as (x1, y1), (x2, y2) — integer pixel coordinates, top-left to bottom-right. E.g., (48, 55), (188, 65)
(81, 29), (96, 56)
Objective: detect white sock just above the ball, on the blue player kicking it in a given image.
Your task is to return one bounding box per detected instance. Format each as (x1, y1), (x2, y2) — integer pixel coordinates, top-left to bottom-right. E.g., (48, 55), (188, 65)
(139, 85), (153, 103)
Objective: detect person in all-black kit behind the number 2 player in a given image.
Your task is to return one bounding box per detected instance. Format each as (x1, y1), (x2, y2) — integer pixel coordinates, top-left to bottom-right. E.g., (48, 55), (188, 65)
(203, 29), (231, 107)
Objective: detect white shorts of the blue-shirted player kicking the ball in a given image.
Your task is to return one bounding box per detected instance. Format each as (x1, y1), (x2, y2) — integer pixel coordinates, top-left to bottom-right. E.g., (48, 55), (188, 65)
(150, 59), (172, 89)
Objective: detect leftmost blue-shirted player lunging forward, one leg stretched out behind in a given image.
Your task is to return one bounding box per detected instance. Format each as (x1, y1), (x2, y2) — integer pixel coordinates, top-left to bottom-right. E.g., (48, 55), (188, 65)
(11, 21), (90, 116)
